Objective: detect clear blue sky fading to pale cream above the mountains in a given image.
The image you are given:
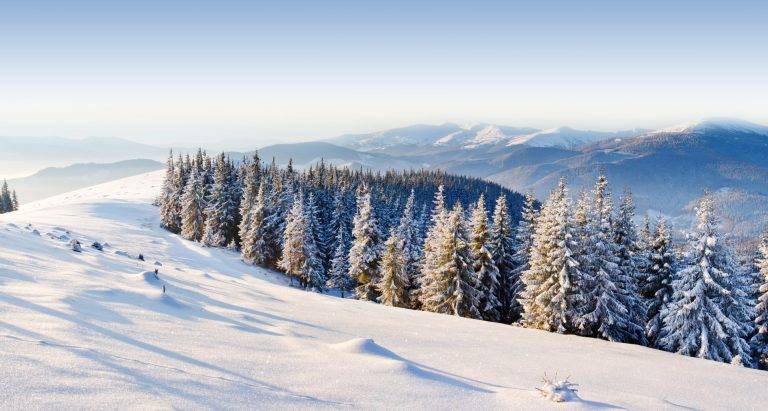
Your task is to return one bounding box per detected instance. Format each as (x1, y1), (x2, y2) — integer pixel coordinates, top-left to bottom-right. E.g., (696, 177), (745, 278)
(0, 0), (768, 143)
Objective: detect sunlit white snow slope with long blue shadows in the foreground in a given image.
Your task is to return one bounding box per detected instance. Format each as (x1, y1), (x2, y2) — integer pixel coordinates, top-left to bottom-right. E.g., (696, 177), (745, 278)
(0, 172), (768, 409)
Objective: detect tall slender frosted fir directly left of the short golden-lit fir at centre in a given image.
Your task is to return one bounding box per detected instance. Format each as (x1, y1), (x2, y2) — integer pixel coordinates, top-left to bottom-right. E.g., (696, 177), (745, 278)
(349, 187), (382, 301)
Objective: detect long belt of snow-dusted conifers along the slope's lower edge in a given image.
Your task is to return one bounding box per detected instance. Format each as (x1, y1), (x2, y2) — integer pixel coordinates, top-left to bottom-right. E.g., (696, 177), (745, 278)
(158, 150), (768, 369)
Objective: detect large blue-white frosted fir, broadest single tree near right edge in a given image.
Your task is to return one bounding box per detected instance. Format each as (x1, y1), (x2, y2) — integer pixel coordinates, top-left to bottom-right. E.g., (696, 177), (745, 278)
(657, 196), (751, 364)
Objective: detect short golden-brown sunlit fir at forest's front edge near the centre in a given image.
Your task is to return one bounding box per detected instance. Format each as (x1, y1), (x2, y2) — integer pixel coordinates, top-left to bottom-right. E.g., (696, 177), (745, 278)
(376, 230), (411, 308)
